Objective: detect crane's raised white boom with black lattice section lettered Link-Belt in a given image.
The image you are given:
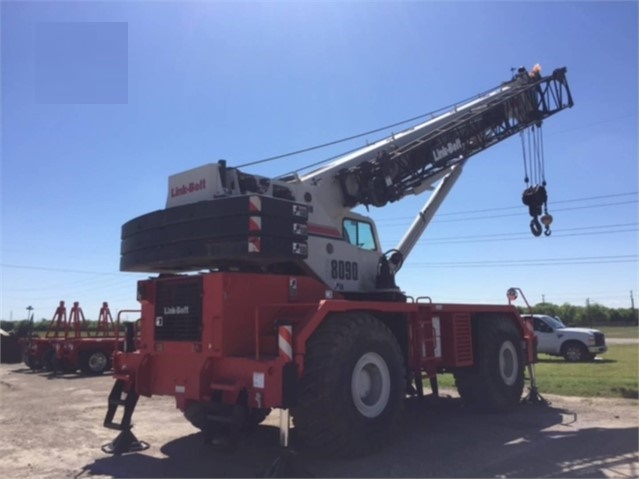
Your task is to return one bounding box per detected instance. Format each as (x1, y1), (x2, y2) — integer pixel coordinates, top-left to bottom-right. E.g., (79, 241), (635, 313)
(302, 67), (573, 207)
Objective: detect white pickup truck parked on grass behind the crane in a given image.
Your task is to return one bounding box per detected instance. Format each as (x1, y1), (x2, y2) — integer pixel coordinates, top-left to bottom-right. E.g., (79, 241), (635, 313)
(522, 314), (608, 362)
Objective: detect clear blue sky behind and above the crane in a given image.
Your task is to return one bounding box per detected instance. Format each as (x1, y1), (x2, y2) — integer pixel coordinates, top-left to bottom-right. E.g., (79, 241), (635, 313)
(0, 1), (639, 319)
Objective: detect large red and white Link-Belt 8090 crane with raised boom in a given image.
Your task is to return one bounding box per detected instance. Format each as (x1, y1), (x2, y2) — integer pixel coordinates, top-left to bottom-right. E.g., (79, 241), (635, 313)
(103, 64), (573, 455)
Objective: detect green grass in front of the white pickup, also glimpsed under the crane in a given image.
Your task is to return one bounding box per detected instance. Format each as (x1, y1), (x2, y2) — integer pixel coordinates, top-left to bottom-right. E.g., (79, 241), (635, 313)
(432, 344), (639, 399)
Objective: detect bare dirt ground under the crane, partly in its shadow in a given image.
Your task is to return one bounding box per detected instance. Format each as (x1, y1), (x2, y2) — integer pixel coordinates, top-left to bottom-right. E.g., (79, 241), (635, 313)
(0, 364), (639, 478)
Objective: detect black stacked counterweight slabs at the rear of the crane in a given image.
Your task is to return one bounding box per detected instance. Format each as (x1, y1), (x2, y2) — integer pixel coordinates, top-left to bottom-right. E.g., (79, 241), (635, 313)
(120, 195), (308, 272)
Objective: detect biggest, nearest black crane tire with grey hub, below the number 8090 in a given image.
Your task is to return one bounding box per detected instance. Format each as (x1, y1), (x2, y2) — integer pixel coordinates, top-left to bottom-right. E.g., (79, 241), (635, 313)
(291, 313), (406, 457)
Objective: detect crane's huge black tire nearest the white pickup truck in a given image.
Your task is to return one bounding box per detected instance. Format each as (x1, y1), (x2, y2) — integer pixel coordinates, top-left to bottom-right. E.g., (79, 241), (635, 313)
(454, 316), (524, 412)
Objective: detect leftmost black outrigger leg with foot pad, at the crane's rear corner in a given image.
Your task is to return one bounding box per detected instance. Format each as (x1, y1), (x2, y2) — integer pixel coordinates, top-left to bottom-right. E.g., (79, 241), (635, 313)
(101, 379), (149, 454)
